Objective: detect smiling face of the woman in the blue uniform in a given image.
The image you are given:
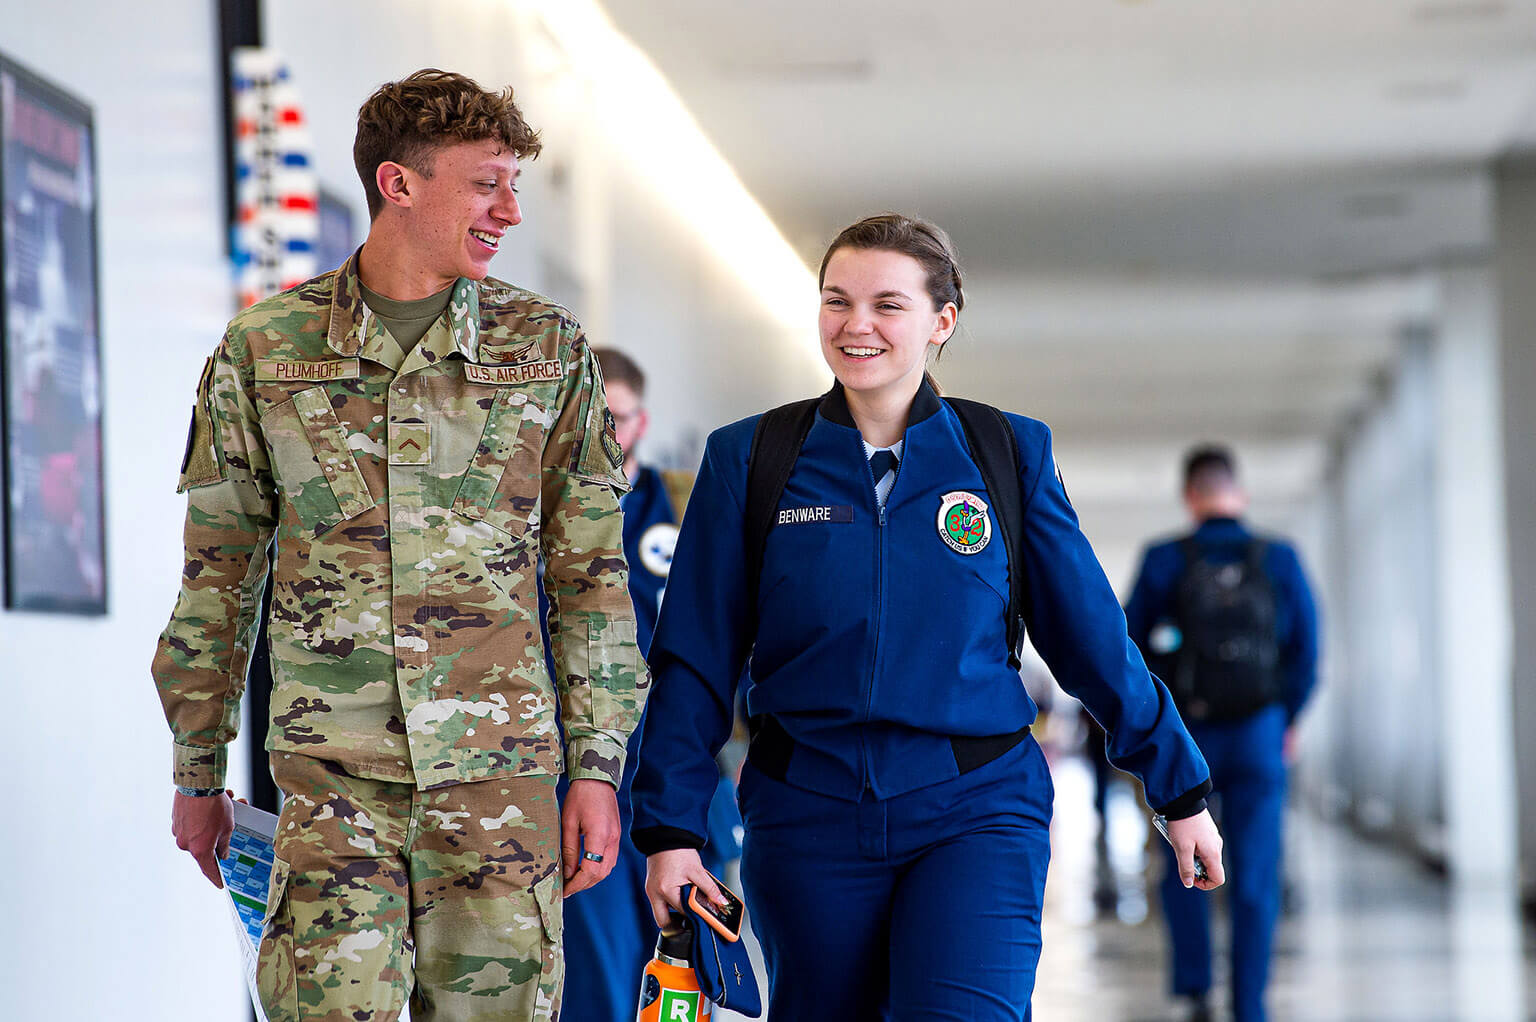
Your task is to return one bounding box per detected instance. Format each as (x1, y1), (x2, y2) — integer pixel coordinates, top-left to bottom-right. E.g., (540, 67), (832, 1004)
(820, 247), (958, 398)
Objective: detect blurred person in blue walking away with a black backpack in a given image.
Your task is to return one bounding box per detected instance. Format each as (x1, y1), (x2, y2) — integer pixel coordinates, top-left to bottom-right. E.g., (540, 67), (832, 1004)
(1126, 447), (1318, 1022)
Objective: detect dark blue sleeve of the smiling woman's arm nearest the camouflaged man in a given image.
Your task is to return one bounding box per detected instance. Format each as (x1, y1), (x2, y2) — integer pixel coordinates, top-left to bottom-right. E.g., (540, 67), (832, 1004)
(630, 427), (751, 854)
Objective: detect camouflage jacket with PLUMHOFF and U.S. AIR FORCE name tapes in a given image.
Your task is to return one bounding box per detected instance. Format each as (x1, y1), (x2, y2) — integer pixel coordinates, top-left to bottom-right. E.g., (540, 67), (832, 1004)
(152, 257), (650, 788)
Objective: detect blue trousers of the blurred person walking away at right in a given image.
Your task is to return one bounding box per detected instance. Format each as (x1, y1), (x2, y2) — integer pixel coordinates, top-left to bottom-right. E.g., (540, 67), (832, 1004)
(1161, 704), (1286, 1022)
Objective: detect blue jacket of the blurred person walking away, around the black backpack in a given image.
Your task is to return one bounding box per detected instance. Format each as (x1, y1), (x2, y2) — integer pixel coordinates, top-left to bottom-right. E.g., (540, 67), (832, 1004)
(1126, 518), (1318, 721)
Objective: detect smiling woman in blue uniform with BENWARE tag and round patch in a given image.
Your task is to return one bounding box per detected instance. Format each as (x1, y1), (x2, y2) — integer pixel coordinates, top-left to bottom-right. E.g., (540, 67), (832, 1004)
(631, 214), (1223, 1022)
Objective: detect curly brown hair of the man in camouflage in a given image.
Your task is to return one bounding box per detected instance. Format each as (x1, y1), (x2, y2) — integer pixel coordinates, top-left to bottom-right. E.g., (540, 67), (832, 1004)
(352, 68), (544, 218)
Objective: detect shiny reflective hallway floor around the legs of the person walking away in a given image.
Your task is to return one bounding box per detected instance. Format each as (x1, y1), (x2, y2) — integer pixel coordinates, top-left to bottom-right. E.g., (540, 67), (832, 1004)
(719, 756), (1536, 1022)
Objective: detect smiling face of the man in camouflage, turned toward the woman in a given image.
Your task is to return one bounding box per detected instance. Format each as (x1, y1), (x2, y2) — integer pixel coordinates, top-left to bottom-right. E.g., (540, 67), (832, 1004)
(390, 138), (522, 287)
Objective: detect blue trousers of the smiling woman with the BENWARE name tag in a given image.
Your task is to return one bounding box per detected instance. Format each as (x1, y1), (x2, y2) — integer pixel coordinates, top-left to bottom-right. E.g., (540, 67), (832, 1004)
(740, 736), (1054, 1022)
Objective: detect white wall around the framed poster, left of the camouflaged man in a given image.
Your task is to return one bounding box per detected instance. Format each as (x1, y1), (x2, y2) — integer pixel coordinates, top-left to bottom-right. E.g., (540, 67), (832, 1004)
(0, 0), (244, 1022)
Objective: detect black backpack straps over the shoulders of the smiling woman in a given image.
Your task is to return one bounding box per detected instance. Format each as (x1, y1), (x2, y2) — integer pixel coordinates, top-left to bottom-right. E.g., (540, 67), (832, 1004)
(743, 395), (1029, 669)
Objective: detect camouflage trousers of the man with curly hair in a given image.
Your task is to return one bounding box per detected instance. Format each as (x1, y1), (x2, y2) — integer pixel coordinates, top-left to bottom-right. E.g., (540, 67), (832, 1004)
(258, 753), (565, 1022)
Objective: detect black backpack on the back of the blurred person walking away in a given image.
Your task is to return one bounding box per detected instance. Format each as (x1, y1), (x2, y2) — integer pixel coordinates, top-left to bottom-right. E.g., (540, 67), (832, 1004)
(1158, 538), (1283, 721)
